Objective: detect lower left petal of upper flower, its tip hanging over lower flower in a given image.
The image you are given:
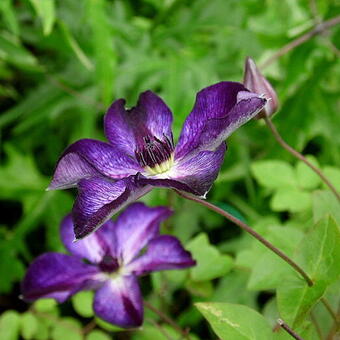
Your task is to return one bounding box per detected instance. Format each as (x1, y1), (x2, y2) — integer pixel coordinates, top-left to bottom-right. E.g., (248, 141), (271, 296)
(72, 176), (151, 239)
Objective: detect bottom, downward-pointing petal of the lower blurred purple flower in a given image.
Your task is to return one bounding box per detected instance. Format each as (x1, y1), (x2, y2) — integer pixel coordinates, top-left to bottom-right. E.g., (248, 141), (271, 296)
(93, 275), (143, 328)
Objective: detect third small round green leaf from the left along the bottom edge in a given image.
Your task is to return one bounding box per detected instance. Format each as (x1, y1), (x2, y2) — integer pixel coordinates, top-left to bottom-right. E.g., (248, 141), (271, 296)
(51, 317), (83, 340)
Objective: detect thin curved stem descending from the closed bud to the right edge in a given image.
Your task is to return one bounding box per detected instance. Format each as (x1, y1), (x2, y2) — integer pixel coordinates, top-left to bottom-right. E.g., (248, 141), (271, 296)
(264, 117), (340, 202)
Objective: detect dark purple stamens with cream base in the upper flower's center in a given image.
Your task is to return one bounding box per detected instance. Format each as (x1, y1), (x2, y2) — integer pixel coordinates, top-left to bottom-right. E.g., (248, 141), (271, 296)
(135, 134), (174, 175)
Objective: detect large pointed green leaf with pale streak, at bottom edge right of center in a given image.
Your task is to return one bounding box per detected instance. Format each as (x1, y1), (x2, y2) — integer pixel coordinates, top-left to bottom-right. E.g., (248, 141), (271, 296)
(196, 302), (272, 340)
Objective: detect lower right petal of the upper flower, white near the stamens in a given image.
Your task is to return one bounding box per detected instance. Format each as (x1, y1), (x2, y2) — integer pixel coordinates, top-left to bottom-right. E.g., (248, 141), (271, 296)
(139, 142), (226, 197)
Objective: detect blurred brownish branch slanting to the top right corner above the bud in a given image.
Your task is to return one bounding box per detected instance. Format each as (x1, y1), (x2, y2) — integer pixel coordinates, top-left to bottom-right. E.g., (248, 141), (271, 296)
(261, 15), (340, 68)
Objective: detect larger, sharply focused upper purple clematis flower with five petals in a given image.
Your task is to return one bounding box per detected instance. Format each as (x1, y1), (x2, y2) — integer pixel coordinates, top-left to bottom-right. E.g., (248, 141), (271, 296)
(49, 82), (266, 239)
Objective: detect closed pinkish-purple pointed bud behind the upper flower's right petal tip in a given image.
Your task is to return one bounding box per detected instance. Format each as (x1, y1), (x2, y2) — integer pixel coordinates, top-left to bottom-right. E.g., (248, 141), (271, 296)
(243, 57), (279, 119)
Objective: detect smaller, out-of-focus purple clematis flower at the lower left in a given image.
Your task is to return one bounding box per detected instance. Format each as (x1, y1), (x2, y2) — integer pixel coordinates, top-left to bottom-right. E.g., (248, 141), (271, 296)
(22, 203), (195, 328)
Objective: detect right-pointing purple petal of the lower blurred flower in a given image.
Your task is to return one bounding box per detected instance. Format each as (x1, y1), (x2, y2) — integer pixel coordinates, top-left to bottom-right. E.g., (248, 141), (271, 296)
(126, 235), (196, 275)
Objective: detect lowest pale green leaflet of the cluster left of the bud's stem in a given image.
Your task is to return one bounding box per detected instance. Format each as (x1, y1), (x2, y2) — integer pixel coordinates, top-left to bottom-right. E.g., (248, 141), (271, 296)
(270, 187), (312, 213)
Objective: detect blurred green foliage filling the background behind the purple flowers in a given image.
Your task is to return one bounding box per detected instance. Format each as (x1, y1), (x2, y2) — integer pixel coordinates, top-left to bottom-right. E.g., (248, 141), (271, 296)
(0, 0), (340, 340)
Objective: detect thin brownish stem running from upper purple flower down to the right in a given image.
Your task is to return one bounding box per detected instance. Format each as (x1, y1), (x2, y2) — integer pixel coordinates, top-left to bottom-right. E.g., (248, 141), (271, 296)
(175, 190), (314, 286)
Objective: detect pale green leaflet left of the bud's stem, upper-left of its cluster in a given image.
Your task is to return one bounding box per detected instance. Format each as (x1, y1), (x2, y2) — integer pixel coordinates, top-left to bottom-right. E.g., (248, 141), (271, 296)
(251, 160), (297, 189)
